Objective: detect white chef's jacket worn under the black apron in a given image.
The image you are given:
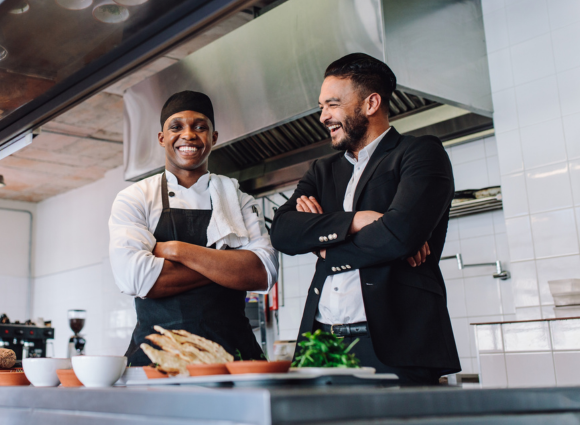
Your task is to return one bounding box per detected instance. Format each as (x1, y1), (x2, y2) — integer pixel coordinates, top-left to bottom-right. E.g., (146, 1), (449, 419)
(109, 171), (278, 298)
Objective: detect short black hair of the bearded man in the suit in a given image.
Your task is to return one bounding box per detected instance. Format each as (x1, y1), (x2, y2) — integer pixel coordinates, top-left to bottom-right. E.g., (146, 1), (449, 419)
(324, 53), (397, 113)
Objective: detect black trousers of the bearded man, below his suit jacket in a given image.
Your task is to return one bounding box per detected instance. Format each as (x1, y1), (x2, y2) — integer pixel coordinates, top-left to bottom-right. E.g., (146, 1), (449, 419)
(314, 321), (442, 385)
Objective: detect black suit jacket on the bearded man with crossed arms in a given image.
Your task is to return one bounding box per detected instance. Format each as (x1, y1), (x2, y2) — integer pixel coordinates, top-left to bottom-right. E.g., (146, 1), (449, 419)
(271, 128), (460, 373)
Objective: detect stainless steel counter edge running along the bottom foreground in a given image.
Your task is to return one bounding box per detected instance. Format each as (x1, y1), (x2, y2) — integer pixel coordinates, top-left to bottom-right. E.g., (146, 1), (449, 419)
(0, 386), (580, 425)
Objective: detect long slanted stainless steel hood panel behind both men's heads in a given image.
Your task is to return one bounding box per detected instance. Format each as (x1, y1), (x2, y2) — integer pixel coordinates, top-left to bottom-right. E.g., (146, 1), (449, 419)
(124, 0), (383, 180)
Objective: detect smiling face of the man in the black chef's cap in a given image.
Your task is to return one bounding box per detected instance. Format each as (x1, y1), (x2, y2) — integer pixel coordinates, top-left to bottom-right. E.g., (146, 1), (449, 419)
(158, 111), (218, 174)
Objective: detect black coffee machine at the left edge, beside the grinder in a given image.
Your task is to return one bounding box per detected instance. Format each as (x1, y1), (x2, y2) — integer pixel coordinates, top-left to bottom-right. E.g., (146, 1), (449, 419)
(0, 323), (54, 360)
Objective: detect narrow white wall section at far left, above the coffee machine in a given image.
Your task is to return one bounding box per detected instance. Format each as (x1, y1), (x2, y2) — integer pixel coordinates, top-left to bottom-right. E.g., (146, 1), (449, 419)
(0, 199), (36, 323)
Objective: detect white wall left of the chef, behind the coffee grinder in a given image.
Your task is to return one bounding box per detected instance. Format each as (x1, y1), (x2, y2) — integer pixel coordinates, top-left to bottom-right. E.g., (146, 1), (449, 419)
(33, 167), (135, 357)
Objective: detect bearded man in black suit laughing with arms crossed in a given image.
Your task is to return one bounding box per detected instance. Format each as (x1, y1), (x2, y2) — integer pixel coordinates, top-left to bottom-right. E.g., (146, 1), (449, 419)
(271, 53), (461, 384)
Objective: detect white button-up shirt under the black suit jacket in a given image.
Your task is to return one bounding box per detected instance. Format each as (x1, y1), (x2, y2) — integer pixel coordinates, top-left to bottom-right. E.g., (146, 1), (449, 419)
(316, 127), (391, 325)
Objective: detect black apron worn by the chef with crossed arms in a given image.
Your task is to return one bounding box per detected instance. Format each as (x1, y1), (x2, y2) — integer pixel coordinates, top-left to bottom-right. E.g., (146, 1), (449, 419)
(125, 173), (262, 366)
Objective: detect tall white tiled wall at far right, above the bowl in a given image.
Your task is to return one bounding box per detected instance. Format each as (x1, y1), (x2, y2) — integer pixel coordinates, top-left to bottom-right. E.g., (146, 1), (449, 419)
(482, 0), (580, 319)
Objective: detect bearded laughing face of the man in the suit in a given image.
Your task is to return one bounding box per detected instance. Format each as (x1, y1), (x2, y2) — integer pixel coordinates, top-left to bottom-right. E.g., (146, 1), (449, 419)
(318, 77), (369, 152)
